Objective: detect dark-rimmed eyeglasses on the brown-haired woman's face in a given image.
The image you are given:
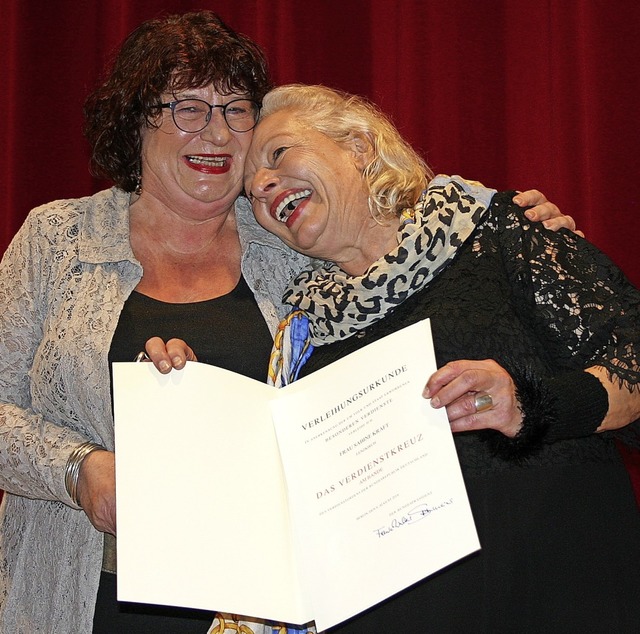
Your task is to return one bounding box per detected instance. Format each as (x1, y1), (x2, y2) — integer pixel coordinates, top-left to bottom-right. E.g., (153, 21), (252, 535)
(159, 99), (260, 132)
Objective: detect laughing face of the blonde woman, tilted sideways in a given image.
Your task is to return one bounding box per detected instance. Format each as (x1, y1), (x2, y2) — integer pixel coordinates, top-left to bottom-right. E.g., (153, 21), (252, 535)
(245, 110), (395, 272)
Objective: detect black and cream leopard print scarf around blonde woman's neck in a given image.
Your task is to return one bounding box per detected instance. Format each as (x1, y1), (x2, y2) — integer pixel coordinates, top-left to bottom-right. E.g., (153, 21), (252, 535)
(283, 176), (495, 346)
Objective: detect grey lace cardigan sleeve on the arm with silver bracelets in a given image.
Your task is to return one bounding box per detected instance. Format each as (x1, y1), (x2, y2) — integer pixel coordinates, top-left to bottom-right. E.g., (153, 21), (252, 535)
(0, 214), (86, 503)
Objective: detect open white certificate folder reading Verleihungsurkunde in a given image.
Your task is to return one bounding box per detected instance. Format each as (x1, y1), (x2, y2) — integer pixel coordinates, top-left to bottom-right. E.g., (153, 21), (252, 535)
(113, 321), (479, 630)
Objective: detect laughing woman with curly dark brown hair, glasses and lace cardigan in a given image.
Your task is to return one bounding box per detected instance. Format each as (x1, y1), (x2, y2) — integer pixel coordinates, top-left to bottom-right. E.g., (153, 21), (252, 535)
(0, 11), (568, 634)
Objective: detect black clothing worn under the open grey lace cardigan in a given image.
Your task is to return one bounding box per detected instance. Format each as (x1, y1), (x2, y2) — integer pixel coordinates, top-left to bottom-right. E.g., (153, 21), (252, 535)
(99, 277), (272, 634)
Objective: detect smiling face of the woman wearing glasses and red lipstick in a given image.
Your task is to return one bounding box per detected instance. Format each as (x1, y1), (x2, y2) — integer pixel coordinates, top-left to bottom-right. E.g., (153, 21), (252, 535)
(142, 86), (252, 213)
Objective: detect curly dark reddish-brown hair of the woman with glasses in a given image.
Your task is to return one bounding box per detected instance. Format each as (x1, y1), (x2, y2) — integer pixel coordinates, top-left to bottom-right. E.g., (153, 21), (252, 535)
(84, 11), (272, 192)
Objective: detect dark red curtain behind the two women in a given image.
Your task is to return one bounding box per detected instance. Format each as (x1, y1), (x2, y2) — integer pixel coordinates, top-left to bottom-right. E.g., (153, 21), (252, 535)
(0, 0), (640, 494)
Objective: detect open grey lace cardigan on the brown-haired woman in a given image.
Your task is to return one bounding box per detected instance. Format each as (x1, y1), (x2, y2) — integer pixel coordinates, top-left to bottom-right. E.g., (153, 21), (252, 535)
(0, 188), (309, 634)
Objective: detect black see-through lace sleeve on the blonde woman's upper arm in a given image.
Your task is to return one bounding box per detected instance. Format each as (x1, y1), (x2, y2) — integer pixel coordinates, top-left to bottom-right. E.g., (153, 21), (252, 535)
(489, 192), (640, 389)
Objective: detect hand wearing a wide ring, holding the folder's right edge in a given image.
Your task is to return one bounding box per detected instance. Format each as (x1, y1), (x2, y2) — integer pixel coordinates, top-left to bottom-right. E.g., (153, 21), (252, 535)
(423, 359), (522, 438)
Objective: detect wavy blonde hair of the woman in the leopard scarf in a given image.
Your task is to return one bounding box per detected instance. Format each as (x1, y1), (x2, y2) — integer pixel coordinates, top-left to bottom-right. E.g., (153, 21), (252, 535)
(260, 84), (433, 222)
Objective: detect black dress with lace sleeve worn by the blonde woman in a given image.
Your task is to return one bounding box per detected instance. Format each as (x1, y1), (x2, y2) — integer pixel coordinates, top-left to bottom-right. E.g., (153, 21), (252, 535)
(303, 193), (640, 634)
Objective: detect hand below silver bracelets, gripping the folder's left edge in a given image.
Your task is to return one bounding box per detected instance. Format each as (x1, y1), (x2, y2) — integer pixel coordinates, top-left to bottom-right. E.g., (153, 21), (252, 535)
(78, 449), (116, 535)
